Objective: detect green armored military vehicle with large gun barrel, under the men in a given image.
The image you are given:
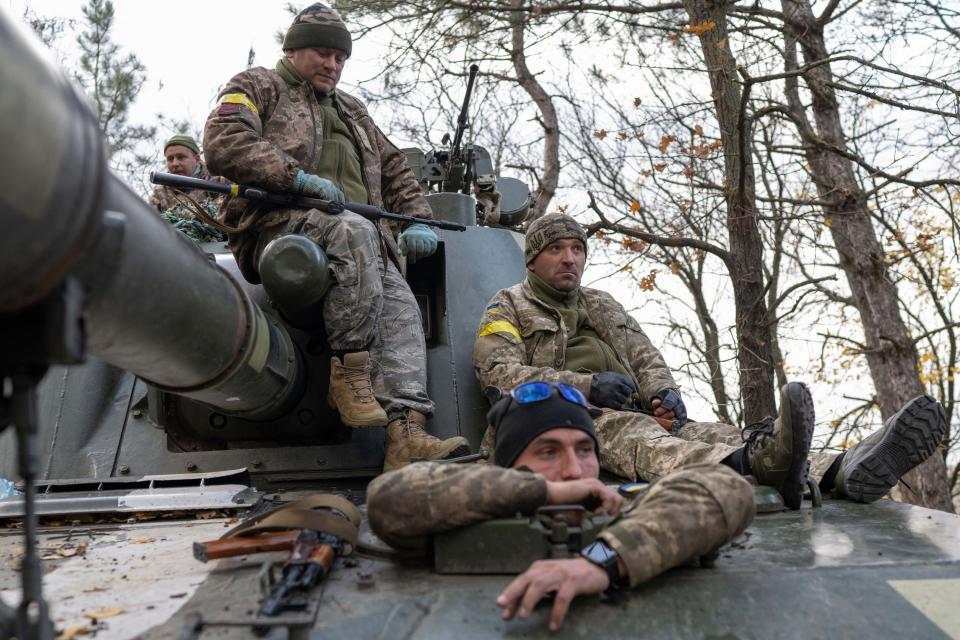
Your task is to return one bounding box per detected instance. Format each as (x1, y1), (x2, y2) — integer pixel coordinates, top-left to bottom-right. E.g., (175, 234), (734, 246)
(0, 14), (960, 639)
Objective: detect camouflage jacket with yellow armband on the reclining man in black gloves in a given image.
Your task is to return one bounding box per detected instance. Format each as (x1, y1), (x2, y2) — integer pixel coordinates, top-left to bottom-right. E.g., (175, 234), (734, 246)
(473, 279), (677, 409)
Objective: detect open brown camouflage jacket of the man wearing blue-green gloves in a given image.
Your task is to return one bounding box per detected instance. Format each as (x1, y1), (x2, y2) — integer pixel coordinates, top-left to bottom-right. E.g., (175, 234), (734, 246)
(203, 67), (432, 282)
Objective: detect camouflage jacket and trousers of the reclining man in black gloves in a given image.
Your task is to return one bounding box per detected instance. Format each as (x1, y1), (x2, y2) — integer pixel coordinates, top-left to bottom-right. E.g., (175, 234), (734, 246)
(473, 280), (743, 480)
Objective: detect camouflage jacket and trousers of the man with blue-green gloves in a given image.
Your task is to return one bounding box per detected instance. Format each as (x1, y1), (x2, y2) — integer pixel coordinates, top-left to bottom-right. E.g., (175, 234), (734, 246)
(204, 62), (433, 419)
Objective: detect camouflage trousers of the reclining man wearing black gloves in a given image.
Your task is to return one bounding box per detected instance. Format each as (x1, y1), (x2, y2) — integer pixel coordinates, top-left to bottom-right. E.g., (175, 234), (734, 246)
(594, 411), (837, 482)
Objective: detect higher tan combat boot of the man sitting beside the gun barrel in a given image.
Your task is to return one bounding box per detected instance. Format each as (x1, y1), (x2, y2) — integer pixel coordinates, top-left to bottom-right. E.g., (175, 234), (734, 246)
(327, 351), (387, 427)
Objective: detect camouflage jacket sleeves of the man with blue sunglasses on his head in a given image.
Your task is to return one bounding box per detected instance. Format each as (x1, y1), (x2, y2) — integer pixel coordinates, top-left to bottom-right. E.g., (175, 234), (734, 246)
(367, 462), (756, 586)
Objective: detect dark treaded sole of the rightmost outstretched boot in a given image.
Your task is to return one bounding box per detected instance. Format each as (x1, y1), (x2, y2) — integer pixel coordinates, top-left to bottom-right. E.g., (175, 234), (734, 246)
(843, 396), (947, 502)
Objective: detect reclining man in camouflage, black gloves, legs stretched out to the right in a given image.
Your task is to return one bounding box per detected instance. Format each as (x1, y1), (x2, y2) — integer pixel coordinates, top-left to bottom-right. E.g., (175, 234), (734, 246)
(474, 215), (946, 509)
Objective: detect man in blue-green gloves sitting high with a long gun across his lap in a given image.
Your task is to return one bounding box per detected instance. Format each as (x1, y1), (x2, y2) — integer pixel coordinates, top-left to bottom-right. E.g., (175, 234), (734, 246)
(204, 3), (468, 469)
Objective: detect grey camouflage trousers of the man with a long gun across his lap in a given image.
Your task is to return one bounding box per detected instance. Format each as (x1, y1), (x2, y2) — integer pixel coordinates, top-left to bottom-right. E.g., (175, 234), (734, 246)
(257, 209), (433, 420)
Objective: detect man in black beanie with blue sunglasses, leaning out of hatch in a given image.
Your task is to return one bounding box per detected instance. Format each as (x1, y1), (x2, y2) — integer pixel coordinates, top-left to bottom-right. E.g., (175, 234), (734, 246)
(367, 382), (754, 630)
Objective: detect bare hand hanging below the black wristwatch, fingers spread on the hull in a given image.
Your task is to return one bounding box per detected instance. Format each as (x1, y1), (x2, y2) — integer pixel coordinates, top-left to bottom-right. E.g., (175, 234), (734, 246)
(497, 558), (610, 631)
